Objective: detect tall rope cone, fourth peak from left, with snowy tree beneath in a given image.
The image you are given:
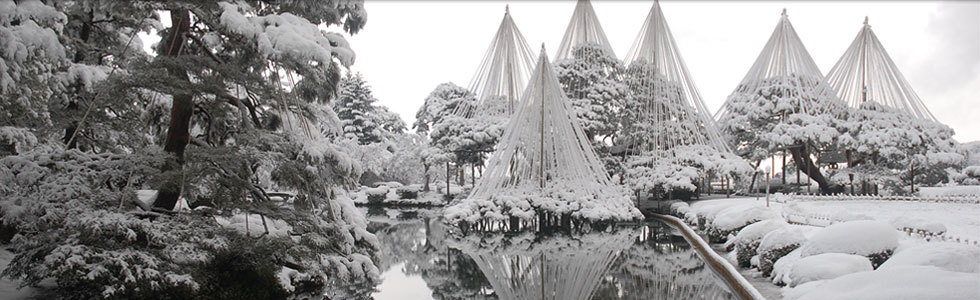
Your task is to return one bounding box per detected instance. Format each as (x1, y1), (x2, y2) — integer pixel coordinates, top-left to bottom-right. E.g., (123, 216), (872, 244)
(616, 1), (748, 196)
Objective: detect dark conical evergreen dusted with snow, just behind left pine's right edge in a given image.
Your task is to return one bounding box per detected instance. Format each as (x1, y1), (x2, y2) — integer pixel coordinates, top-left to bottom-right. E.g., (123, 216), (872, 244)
(333, 74), (381, 145)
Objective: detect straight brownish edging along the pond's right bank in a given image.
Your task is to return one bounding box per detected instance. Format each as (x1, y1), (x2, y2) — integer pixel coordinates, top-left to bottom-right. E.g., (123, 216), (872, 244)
(650, 214), (766, 300)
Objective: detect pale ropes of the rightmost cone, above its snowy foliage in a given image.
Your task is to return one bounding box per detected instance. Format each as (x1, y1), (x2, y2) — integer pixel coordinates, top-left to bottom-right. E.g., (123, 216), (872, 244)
(827, 18), (936, 121)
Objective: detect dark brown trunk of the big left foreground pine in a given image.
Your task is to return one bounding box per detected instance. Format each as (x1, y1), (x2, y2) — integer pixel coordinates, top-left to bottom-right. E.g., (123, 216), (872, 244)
(153, 9), (194, 210)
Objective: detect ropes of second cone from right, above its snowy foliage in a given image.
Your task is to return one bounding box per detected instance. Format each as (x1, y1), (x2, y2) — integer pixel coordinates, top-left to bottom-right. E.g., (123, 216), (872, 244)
(715, 9), (840, 120)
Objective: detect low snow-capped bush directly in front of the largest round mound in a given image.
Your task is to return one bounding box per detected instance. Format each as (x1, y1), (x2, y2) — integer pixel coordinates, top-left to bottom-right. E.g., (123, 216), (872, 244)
(789, 253), (872, 286)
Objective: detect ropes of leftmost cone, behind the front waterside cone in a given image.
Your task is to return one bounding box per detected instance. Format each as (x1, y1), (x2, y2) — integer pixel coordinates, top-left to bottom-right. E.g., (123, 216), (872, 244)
(459, 9), (534, 117)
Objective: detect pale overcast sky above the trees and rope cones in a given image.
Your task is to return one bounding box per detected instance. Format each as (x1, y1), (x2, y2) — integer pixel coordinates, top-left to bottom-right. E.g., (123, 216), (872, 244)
(349, 0), (980, 142)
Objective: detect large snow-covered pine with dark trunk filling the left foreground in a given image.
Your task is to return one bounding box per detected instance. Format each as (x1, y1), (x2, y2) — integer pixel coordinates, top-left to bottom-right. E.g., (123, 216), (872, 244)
(0, 1), (378, 299)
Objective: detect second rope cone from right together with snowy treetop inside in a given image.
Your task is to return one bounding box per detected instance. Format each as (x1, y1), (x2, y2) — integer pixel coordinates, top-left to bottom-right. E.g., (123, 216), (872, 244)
(715, 12), (845, 159)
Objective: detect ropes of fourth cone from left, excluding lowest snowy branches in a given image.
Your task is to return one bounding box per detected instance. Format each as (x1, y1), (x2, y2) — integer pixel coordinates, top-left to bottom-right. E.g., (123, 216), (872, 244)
(625, 2), (728, 151)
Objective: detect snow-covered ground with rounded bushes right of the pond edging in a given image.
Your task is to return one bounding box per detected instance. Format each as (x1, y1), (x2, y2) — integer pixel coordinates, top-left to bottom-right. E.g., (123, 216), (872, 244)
(673, 196), (980, 299)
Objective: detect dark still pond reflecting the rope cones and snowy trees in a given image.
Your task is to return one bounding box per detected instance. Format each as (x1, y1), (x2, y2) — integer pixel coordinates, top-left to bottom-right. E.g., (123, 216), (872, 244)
(368, 209), (737, 300)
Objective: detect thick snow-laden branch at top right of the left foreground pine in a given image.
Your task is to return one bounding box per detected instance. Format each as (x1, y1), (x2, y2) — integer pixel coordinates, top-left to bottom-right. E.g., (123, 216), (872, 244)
(219, 2), (354, 67)
